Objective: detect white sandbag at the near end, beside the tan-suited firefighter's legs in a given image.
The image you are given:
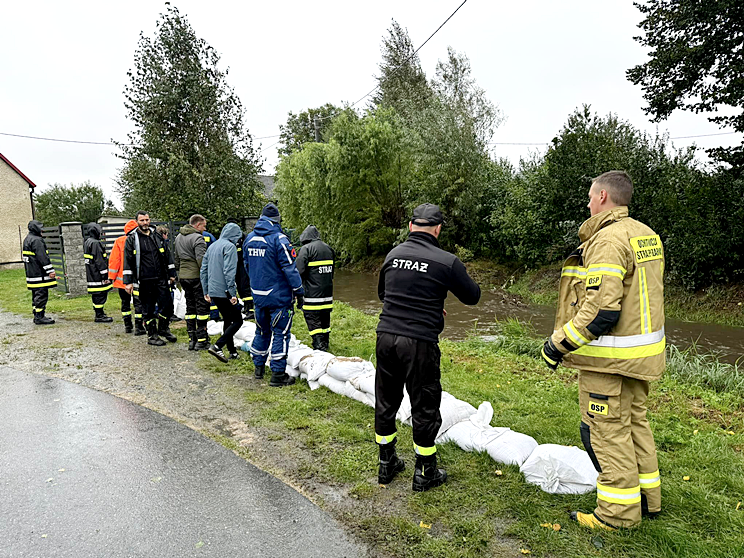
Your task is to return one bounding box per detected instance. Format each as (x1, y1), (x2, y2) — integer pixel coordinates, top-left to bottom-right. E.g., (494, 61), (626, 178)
(519, 444), (597, 494)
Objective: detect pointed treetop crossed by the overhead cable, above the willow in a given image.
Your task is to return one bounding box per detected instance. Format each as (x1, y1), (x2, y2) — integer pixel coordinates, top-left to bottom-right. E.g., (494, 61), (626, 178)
(372, 20), (432, 121)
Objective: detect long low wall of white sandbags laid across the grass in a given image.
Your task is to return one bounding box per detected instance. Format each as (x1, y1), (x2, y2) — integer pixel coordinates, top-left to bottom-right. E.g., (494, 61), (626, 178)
(207, 321), (597, 494)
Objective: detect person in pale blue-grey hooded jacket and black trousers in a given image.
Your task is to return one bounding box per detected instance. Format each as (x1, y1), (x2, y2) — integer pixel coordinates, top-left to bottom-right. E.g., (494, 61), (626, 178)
(200, 223), (243, 362)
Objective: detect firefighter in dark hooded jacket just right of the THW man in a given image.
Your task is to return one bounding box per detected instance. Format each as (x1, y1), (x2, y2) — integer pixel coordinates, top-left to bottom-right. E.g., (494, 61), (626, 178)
(296, 225), (336, 351)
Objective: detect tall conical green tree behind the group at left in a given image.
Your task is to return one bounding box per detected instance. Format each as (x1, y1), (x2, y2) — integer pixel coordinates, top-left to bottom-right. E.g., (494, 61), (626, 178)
(119, 6), (261, 224)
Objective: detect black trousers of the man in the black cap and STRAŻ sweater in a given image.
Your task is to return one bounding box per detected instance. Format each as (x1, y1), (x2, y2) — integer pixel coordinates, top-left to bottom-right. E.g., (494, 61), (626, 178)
(375, 333), (442, 455)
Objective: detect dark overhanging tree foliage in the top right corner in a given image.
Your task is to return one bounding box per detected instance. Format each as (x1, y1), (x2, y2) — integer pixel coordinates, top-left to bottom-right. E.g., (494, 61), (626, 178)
(627, 0), (744, 172)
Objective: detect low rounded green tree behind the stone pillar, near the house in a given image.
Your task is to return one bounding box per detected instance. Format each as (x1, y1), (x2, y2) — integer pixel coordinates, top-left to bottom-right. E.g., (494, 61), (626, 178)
(34, 181), (119, 227)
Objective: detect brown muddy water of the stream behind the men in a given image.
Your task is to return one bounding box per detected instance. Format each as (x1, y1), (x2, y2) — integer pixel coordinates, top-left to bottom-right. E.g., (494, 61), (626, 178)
(333, 270), (744, 368)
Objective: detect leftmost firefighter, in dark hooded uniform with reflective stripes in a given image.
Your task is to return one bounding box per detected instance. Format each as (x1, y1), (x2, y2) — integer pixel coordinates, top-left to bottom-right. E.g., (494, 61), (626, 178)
(21, 221), (57, 325)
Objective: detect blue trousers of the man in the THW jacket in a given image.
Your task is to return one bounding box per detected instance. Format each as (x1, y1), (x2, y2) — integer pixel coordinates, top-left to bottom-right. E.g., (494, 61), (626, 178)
(251, 306), (294, 374)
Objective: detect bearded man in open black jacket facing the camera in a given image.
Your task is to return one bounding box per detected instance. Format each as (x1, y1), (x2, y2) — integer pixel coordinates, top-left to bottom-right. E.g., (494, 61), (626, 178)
(123, 211), (176, 346)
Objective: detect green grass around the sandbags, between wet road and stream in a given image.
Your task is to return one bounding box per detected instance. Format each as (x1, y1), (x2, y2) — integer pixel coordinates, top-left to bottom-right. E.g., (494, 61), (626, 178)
(0, 272), (744, 558)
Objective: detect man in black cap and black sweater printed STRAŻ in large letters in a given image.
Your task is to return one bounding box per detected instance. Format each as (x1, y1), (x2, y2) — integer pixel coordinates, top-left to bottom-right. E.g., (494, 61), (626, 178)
(375, 203), (480, 492)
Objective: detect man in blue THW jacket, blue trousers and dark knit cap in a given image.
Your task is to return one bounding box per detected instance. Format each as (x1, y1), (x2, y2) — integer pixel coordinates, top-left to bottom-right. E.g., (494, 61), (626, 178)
(243, 203), (304, 387)
